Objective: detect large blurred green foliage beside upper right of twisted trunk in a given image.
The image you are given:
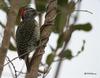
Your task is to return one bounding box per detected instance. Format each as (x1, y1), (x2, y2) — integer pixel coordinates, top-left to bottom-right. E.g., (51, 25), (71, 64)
(53, 0), (75, 33)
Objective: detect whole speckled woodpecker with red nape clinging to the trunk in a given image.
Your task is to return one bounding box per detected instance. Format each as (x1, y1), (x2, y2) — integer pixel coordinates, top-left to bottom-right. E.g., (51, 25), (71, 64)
(16, 7), (40, 70)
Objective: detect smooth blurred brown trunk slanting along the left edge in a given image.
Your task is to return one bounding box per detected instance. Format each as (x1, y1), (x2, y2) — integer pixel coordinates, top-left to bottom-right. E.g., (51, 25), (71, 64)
(0, 1), (18, 77)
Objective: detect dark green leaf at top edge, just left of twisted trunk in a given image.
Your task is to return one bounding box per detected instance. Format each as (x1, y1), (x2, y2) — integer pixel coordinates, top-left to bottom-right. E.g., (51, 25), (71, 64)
(35, 0), (47, 13)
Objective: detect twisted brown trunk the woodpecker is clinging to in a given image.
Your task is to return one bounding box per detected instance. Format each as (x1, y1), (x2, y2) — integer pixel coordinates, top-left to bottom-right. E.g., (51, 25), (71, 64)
(26, 0), (57, 78)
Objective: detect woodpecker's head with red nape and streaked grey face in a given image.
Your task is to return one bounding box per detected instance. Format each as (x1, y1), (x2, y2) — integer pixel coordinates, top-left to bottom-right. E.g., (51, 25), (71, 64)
(19, 7), (38, 20)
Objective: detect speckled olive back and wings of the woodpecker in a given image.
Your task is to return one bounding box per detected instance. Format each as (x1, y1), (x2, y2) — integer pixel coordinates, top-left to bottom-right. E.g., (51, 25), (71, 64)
(16, 21), (37, 59)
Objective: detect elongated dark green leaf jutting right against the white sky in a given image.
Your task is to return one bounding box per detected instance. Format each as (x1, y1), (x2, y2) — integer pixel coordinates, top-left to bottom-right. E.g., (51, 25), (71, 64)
(73, 23), (92, 32)
